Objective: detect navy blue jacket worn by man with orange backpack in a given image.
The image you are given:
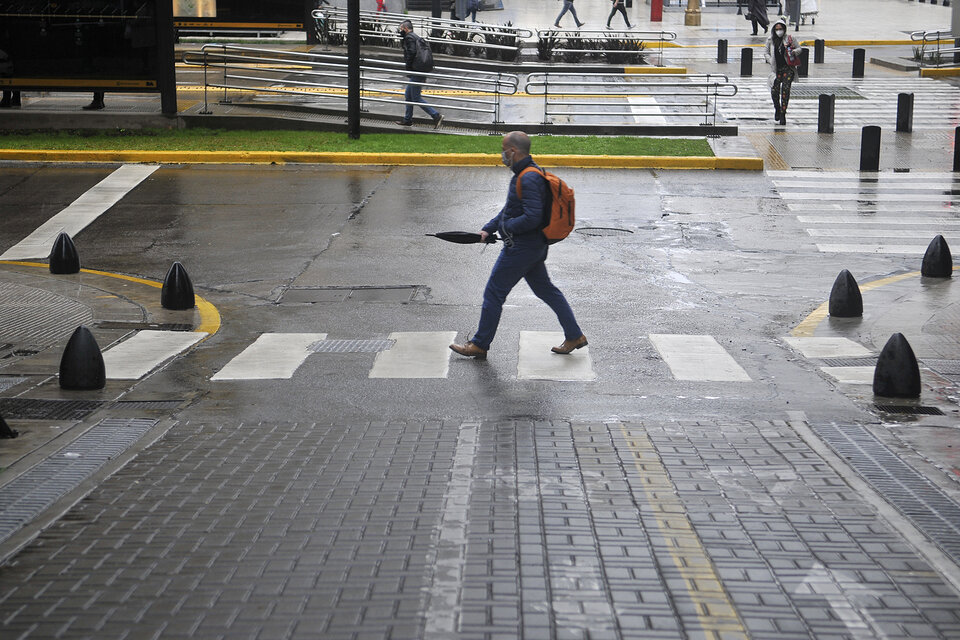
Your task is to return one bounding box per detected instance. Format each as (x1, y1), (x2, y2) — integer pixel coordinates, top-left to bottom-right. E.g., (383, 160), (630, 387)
(483, 156), (547, 246)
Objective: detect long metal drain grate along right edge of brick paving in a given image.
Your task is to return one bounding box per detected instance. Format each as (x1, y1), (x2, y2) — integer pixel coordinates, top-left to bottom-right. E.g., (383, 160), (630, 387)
(810, 424), (960, 562)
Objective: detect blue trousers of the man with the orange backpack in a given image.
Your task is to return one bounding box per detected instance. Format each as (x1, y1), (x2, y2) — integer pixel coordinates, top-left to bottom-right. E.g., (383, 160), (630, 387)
(470, 244), (583, 349)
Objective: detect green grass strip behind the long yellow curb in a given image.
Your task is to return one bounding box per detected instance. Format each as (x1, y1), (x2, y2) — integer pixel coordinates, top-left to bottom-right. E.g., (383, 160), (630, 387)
(0, 129), (714, 157)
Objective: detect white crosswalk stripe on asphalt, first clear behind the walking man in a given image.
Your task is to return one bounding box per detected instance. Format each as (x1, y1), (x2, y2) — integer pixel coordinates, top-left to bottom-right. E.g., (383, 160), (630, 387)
(650, 333), (751, 382)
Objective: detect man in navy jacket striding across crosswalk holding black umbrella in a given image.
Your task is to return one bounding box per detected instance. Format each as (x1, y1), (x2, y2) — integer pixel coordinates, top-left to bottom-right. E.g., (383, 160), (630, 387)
(450, 131), (587, 360)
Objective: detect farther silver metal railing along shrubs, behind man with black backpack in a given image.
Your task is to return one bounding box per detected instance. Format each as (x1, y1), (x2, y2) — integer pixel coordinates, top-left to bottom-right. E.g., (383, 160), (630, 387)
(311, 7), (533, 61)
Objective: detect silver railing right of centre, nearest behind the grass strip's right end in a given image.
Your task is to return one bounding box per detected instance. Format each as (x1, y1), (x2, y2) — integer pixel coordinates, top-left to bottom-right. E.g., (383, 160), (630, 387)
(524, 73), (737, 124)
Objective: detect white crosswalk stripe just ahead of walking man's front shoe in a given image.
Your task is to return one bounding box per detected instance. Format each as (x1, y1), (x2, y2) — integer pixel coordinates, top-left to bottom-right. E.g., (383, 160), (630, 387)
(370, 331), (457, 378)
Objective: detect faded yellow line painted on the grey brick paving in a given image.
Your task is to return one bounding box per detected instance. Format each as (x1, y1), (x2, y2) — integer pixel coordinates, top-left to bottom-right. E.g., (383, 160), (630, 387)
(620, 424), (749, 640)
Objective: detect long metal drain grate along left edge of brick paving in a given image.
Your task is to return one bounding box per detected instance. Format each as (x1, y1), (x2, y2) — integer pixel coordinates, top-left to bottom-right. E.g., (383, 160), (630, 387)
(0, 419), (157, 543)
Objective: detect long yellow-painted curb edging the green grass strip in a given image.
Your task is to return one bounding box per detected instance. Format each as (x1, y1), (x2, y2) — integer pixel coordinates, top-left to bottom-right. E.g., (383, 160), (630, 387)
(0, 149), (763, 171)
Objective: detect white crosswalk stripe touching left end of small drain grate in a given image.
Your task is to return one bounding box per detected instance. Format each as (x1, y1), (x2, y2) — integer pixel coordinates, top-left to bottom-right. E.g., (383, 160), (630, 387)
(210, 333), (327, 380)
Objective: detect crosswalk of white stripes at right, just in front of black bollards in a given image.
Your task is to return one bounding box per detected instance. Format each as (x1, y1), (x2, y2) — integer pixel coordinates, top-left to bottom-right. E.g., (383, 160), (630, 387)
(769, 171), (960, 255)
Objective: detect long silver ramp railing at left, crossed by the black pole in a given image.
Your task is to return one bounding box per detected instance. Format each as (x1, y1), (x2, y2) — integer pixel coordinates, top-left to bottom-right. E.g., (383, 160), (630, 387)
(183, 44), (520, 123)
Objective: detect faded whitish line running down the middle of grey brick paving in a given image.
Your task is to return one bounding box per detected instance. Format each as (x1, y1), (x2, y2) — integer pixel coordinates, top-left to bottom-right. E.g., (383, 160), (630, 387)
(423, 420), (480, 640)
